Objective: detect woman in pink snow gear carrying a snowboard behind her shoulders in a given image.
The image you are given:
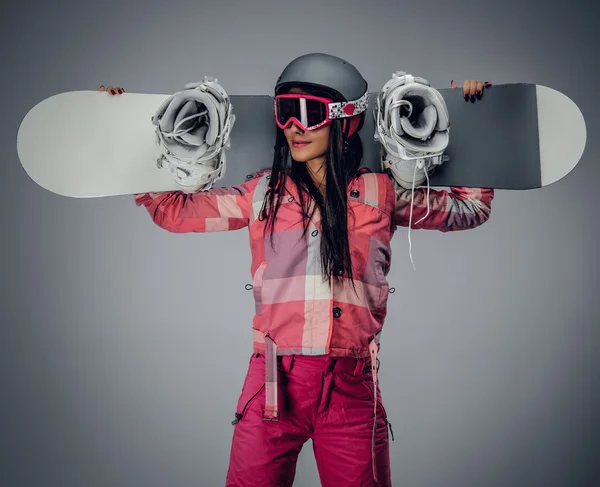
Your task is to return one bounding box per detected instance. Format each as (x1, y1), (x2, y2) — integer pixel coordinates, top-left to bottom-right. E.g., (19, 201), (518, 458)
(102, 54), (494, 487)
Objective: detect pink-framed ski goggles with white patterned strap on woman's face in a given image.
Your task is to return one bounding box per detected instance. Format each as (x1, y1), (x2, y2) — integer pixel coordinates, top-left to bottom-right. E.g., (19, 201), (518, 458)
(275, 93), (368, 130)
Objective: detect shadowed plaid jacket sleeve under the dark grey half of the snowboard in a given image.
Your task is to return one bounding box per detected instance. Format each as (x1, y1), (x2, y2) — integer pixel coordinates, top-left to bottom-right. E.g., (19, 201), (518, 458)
(393, 181), (494, 232)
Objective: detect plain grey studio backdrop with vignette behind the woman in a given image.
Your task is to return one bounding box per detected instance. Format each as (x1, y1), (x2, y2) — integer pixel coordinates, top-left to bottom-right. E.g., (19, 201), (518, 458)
(0, 0), (600, 487)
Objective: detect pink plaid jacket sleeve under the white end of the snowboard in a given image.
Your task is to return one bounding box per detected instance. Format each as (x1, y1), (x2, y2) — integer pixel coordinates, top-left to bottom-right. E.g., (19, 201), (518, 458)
(134, 171), (266, 233)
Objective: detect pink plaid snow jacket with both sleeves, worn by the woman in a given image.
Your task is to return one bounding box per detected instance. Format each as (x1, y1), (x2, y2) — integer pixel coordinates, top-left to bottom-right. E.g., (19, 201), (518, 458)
(135, 169), (494, 357)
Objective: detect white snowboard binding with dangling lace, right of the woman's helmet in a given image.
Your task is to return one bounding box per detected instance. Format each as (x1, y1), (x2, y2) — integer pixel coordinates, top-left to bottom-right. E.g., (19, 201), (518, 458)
(373, 71), (450, 189)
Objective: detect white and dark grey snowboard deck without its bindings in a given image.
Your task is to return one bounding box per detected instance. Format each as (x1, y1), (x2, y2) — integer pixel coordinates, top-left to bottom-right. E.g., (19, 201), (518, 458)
(17, 83), (586, 198)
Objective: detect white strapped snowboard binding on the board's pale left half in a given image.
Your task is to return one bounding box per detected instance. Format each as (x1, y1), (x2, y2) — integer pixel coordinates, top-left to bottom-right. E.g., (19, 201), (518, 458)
(152, 76), (235, 193)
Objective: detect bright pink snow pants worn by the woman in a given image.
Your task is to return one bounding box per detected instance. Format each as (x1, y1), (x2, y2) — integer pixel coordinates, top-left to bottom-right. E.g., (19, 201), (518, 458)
(225, 353), (392, 487)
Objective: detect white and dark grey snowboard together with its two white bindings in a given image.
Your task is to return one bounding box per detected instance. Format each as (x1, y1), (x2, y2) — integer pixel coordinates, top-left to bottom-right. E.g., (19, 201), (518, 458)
(17, 76), (586, 198)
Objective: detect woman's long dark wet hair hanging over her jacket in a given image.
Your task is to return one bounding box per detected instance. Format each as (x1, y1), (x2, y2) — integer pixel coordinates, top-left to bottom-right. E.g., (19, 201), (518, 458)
(259, 86), (364, 285)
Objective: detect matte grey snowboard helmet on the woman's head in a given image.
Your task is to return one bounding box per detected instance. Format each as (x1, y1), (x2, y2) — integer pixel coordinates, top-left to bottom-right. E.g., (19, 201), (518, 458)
(275, 53), (368, 138)
